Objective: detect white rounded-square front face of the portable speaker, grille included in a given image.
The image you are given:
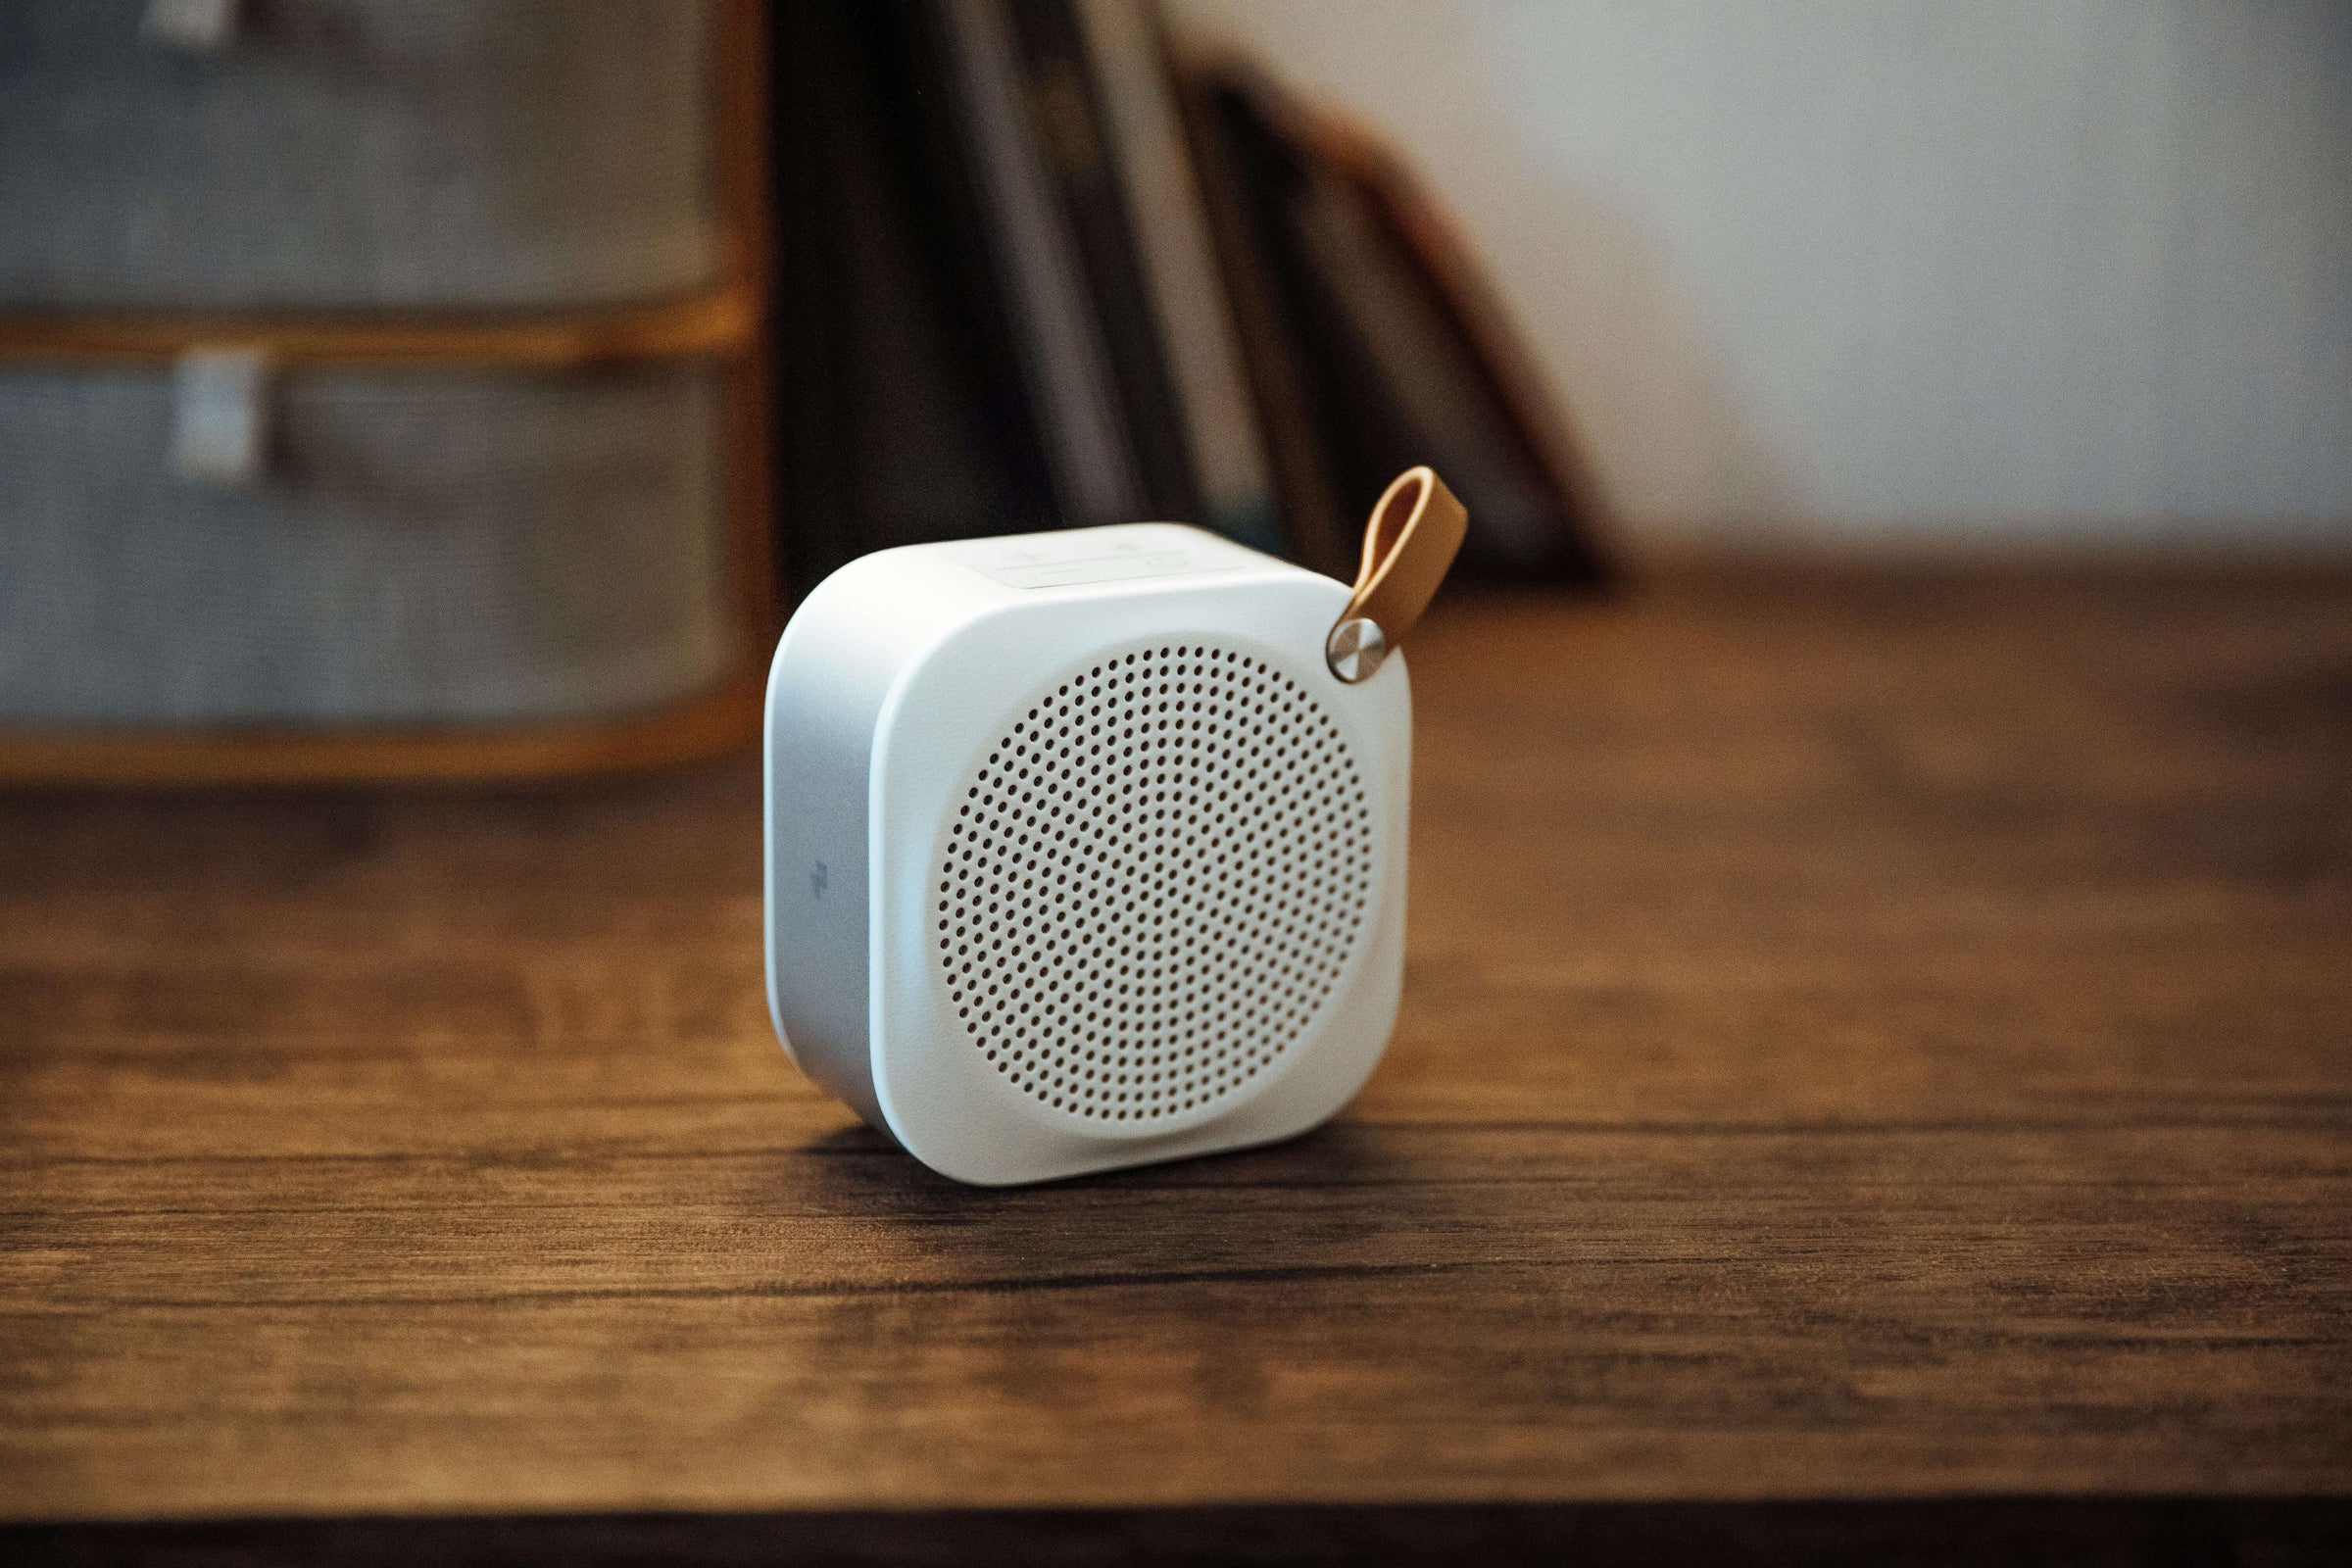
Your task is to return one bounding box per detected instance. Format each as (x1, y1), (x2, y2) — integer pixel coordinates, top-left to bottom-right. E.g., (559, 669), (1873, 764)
(870, 573), (1411, 1183)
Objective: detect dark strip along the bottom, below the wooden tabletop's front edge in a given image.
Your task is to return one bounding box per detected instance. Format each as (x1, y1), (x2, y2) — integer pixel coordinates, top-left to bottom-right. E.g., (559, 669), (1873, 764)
(0, 1495), (2352, 1568)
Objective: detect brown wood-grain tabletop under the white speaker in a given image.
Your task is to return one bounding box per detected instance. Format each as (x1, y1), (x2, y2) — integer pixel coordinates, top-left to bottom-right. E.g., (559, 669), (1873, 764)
(0, 573), (2352, 1563)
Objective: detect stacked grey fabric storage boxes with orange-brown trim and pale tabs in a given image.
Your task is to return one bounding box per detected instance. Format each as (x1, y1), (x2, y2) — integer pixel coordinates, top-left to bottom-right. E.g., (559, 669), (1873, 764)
(0, 0), (769, 780)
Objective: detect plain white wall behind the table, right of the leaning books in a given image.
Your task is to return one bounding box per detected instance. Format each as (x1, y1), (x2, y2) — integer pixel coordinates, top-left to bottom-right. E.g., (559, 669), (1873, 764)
(1171, 0), (2352, 546)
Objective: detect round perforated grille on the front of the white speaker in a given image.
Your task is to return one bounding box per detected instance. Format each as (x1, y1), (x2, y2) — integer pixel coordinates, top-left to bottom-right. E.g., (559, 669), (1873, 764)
(934, 642), (1374, 1126)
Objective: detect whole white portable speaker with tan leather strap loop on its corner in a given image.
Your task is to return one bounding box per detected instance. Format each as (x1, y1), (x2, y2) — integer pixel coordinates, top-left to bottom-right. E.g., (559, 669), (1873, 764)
(764, 467), (1463, 1185)
